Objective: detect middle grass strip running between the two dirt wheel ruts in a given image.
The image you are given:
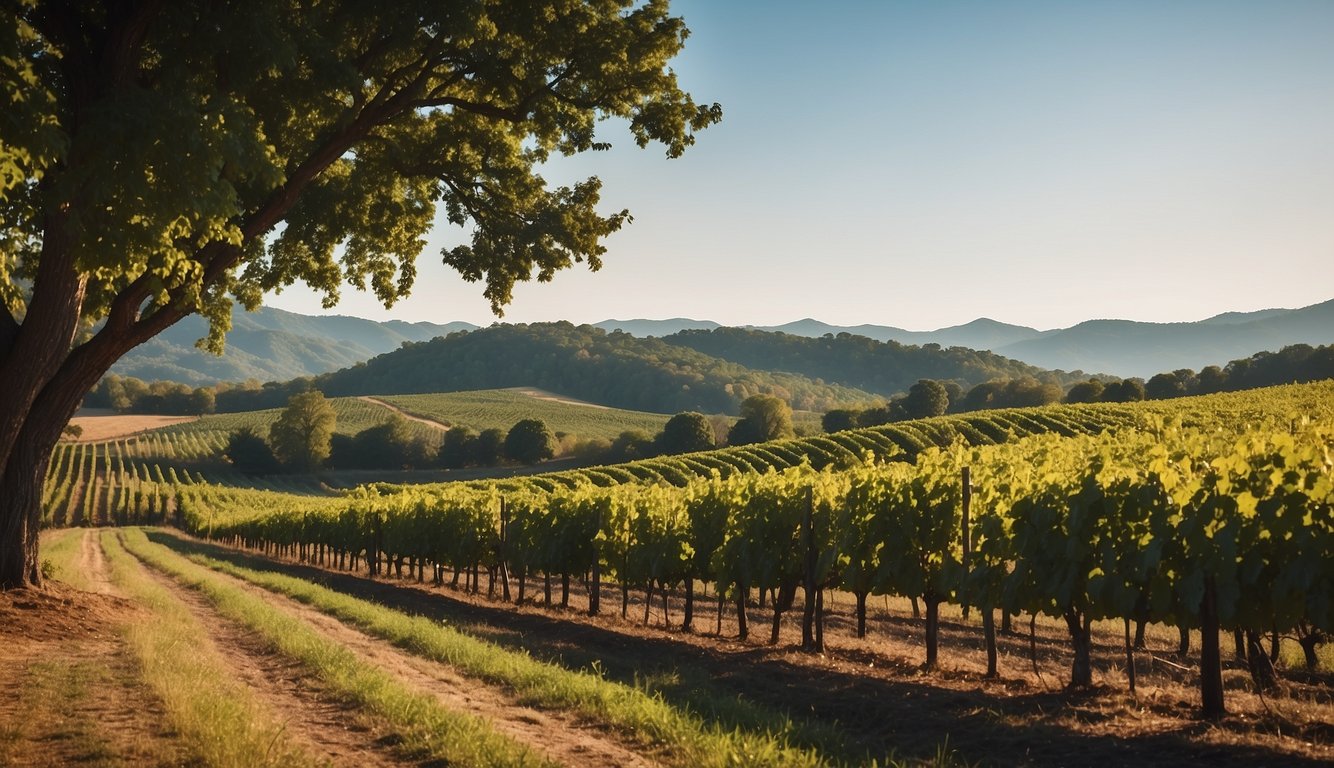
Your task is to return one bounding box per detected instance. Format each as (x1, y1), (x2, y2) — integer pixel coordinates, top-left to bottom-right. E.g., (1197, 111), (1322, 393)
(123, 529), (544, 765)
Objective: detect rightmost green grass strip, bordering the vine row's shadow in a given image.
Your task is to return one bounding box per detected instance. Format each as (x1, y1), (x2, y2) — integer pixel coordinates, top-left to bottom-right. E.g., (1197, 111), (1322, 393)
(153, 533), (842, 765)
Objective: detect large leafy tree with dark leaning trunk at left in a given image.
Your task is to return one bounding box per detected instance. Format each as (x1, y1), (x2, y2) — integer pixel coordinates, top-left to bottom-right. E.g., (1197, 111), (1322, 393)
(0, 0), (720, 587)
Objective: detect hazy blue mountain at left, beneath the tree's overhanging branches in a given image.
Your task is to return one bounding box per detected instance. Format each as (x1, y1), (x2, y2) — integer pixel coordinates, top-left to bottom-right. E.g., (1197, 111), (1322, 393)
(111, 307), (478, 384)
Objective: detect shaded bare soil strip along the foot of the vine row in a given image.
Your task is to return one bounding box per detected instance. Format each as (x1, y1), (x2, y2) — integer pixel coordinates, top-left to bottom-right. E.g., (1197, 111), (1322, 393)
(164, 533), (1327, 767)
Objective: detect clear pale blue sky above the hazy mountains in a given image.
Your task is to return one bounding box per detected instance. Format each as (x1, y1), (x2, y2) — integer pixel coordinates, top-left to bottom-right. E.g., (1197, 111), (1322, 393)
(267, 0), (1334, 329)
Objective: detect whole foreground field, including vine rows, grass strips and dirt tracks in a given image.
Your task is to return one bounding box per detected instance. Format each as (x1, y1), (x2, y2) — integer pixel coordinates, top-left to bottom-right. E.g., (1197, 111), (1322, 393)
(20, 383), (1334, 765)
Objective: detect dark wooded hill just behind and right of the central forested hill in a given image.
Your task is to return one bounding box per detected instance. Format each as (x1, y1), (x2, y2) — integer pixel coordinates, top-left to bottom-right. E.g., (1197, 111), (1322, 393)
(663, 328), (1087, 396)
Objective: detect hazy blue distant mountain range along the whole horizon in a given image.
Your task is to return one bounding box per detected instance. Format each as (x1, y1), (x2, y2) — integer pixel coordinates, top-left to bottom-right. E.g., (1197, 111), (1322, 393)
(112, 300), (1334, 384)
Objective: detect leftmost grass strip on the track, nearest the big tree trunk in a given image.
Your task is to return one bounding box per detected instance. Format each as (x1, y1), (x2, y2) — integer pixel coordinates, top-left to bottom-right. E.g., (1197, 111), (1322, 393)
(98, 531), (316, 767)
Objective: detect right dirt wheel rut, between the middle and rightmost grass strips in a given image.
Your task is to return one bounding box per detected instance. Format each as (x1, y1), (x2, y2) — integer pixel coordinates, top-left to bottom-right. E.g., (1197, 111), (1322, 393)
(143, 533), (656, 768)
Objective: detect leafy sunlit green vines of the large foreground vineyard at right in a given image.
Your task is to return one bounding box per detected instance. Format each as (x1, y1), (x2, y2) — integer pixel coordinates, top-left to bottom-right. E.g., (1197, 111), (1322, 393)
(158, 385), (1334, 712)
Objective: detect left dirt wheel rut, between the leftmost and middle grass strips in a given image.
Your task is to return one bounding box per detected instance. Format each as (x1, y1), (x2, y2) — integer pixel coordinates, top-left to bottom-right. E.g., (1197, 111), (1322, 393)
(119, 538), (410, 768)
